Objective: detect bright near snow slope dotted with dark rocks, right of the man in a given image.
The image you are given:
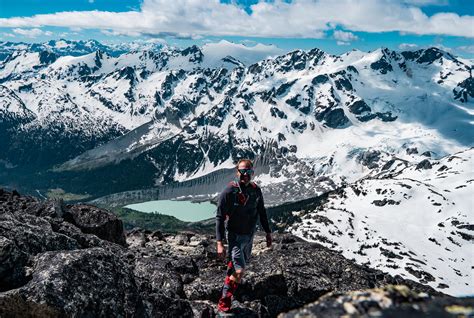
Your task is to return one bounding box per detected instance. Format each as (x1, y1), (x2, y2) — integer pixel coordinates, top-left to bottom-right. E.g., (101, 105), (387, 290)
(289, 148), (474, 295)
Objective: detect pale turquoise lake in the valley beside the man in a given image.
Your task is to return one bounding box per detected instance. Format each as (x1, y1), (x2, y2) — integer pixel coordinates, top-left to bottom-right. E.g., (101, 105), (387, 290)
(125, 200), (216, 222)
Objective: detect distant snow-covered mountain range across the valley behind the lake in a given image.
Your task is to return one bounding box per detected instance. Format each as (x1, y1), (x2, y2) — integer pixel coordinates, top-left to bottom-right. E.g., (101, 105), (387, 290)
(0, 42), (474, 196)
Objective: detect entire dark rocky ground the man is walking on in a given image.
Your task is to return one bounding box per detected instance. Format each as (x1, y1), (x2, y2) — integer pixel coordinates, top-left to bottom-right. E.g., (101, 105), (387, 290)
(0, 189), (474, 317)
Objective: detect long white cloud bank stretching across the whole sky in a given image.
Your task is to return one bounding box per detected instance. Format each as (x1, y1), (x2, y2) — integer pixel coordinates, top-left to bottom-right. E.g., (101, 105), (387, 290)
(0, 0), (474, 38)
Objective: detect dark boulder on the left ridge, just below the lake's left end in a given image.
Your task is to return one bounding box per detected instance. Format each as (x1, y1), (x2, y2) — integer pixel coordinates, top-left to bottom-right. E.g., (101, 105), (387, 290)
(64, 204), (125, 245)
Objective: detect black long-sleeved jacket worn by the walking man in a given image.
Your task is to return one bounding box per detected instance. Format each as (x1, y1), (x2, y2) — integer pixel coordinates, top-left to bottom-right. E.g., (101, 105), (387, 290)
(216, 181), (271, 241)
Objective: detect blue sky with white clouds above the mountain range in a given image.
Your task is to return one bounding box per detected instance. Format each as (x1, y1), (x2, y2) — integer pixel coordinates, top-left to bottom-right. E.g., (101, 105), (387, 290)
(0, 0), (474, 59)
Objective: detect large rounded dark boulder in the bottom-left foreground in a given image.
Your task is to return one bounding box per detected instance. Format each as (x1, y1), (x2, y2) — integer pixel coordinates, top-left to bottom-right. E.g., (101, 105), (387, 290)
(0, 248), (142, 317)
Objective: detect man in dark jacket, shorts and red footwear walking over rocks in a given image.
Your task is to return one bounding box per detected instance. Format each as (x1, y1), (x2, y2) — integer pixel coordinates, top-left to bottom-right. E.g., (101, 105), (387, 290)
(216, 159), (272, 313)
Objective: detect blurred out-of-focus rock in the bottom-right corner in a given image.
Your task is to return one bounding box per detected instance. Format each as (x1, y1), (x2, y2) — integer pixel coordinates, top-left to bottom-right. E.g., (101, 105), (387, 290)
(280, 285), (474, 318)
